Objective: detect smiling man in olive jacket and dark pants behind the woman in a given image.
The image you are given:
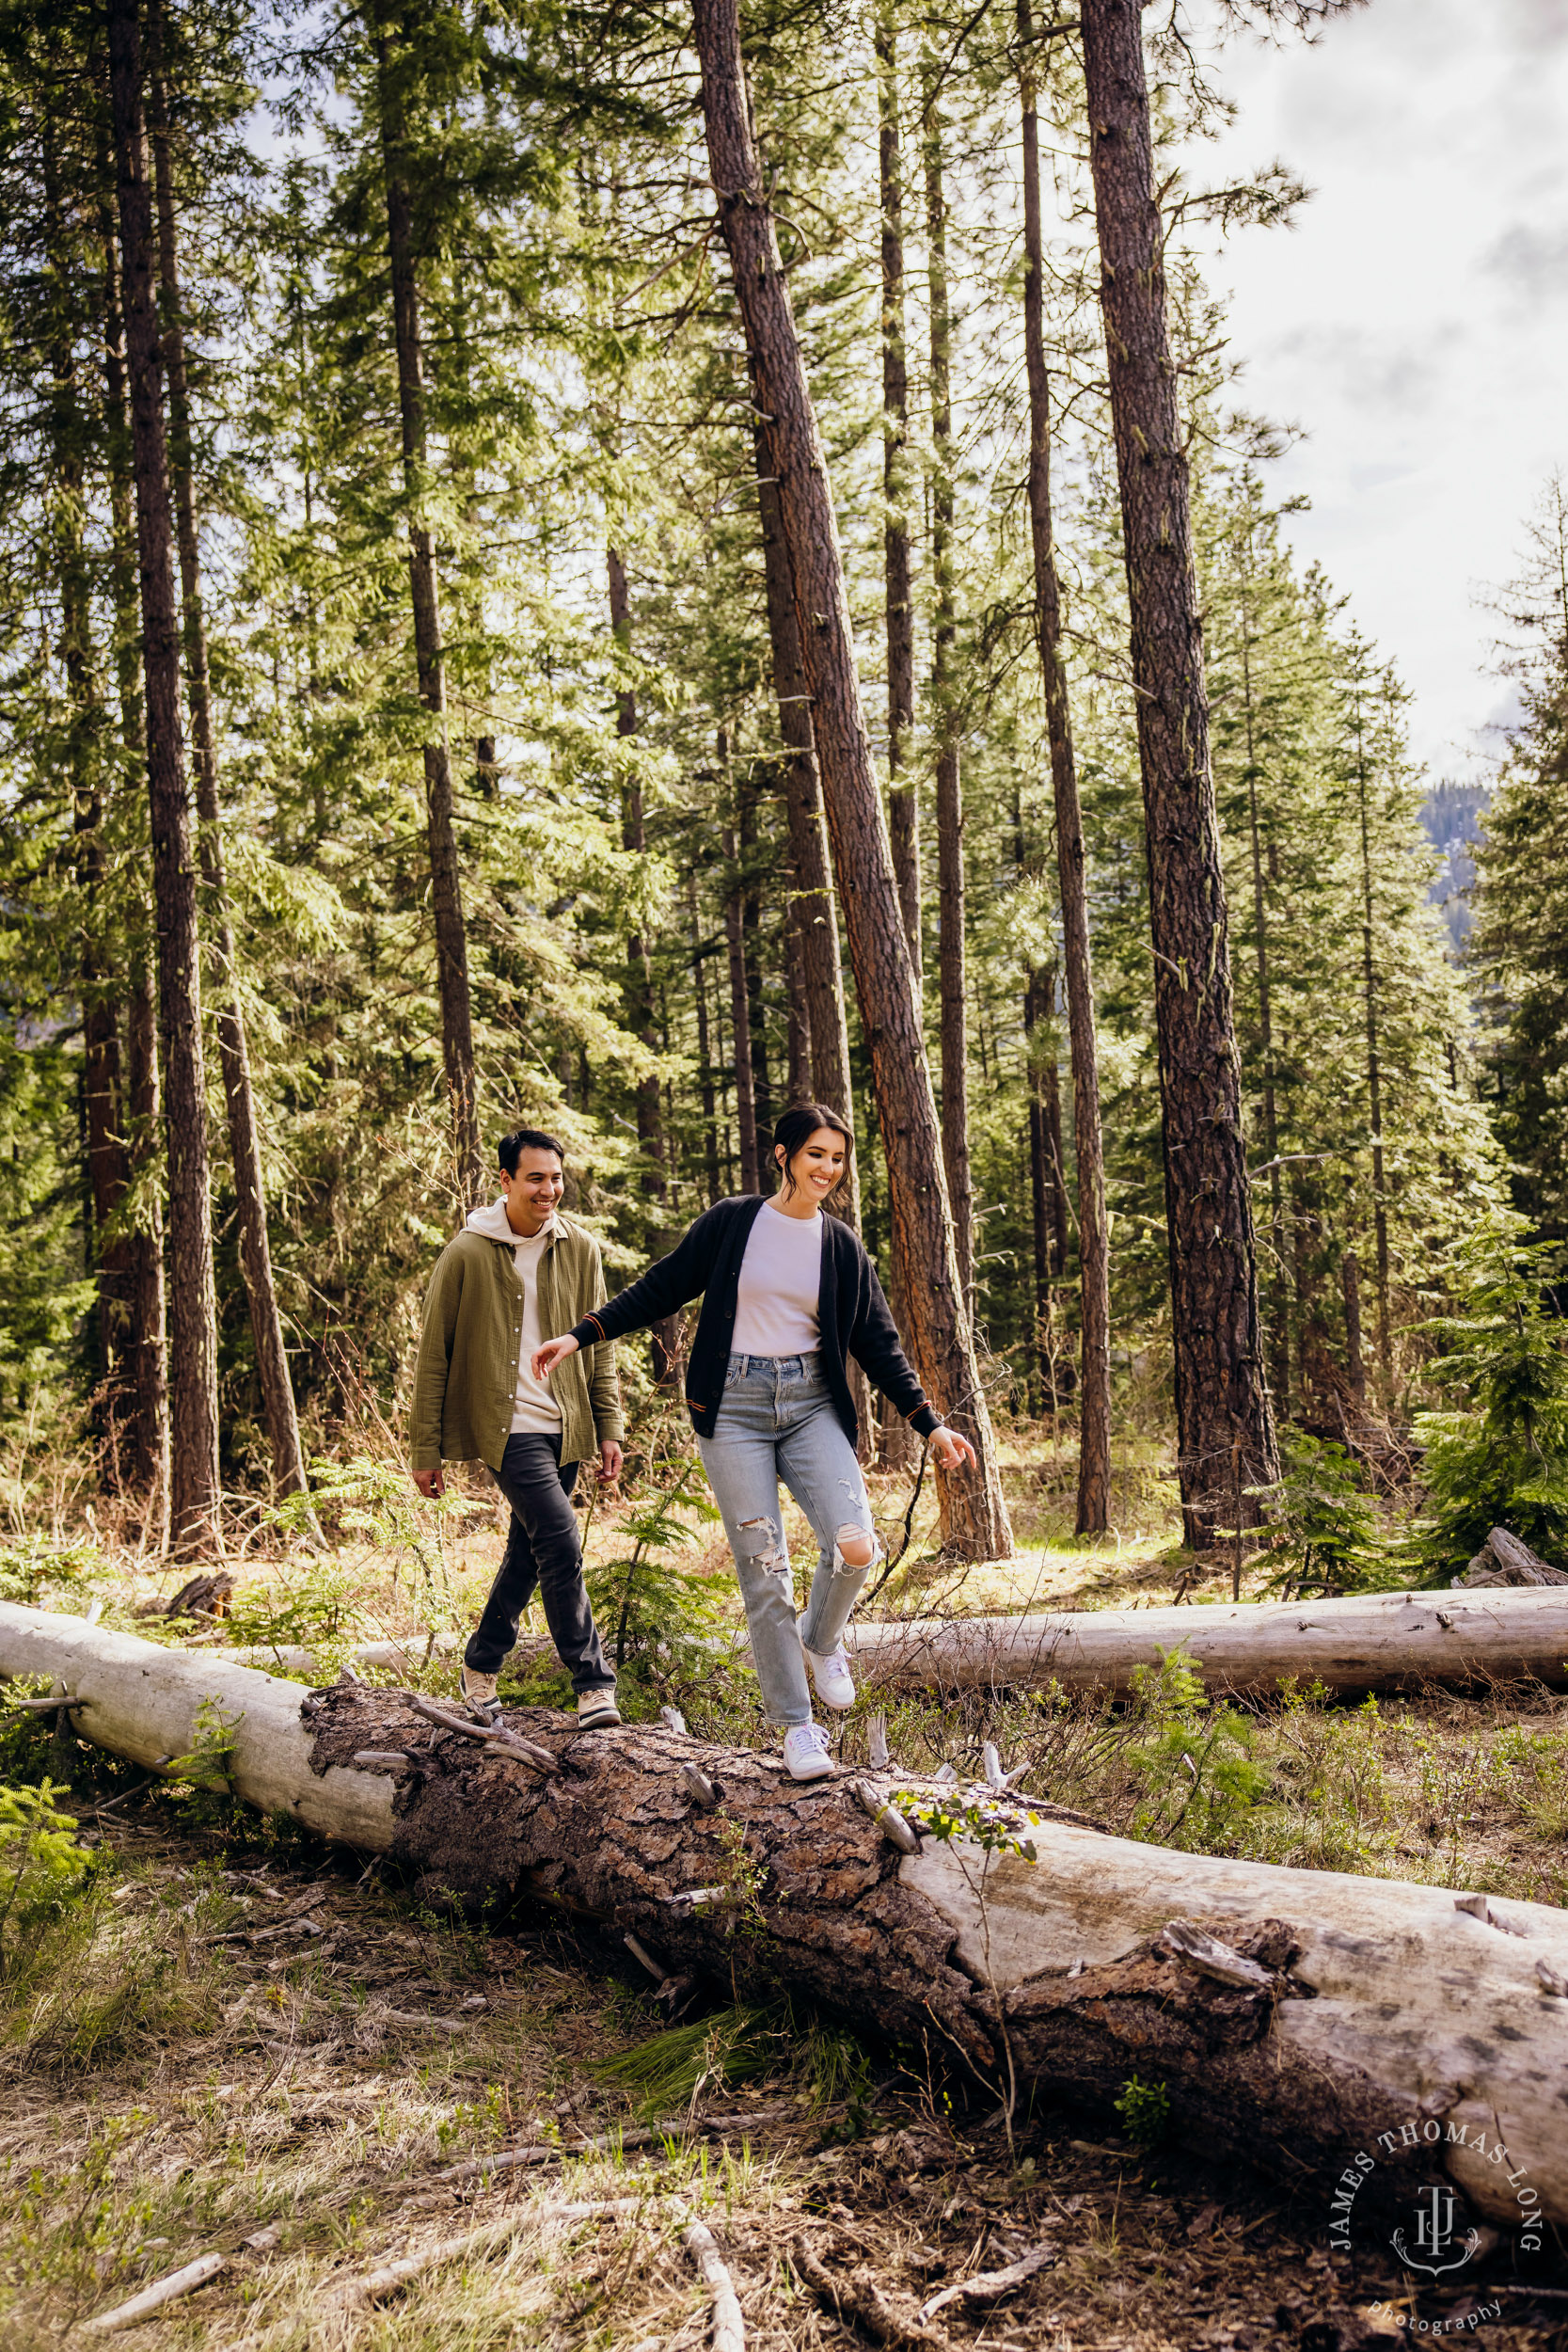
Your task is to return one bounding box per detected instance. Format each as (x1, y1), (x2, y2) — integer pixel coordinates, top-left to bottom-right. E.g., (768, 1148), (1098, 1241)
(409, 1127), (623, 1731)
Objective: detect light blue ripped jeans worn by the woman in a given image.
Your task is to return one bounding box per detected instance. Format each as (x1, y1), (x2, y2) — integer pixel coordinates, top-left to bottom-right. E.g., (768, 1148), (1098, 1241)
(698, 1355), (875, 1724)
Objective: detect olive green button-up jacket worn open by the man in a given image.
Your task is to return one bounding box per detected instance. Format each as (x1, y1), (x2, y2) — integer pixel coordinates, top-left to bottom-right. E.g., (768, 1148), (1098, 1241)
(409, 1209), (623, 1470)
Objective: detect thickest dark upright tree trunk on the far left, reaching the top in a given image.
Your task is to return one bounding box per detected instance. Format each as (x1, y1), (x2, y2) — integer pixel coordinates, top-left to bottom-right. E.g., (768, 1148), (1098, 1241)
(108, 0), (221, 1552)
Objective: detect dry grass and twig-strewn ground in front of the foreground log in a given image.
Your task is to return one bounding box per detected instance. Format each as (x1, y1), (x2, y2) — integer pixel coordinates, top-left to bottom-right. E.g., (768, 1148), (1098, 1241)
(0, 1800), (1568, 2352)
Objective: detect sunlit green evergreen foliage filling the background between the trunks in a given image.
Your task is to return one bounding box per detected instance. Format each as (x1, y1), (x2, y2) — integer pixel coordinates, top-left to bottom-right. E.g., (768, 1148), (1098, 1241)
(0, 0), (1523, 1524)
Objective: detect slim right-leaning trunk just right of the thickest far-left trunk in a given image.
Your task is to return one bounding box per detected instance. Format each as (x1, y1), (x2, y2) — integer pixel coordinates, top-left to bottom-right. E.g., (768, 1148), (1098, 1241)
(148, 23), (308, 1494)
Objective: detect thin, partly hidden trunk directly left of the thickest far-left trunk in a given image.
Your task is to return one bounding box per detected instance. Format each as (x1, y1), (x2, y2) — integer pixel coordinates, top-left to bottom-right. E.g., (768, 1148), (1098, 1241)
(99, 179), (169, 1505)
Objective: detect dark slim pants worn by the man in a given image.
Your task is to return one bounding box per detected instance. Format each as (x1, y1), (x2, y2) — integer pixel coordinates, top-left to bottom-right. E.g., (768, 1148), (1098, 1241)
(463, 1430), (616, 1692)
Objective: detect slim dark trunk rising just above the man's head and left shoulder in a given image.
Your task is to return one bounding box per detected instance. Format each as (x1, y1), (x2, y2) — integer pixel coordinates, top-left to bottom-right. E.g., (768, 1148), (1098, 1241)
(373, 26), (484, 1209)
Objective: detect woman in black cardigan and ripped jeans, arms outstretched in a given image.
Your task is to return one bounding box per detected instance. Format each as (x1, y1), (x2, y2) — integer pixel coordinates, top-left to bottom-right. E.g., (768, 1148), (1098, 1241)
(533, 1104), (975, 1781)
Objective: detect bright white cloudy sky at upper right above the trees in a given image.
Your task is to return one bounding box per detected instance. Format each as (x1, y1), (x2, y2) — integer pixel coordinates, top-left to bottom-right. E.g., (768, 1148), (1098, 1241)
(1192, 0), (1568, 776)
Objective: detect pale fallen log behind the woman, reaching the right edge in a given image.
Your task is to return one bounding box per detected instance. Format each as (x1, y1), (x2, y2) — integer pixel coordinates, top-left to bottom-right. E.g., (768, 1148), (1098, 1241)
(847, 1590), (1568, 1696)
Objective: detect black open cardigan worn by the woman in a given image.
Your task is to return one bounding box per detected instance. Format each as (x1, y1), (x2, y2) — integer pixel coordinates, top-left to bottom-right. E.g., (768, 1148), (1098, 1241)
(571, 1193), (942, 1444)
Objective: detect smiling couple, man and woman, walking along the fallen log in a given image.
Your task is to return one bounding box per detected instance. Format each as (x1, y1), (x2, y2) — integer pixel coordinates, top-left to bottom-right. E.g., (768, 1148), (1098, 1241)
(411, 1104), (974, 1781)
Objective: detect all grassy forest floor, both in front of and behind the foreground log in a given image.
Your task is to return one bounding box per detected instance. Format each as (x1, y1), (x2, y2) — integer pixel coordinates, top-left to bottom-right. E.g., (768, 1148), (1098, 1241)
(0, 1456), (1568, 2352)
